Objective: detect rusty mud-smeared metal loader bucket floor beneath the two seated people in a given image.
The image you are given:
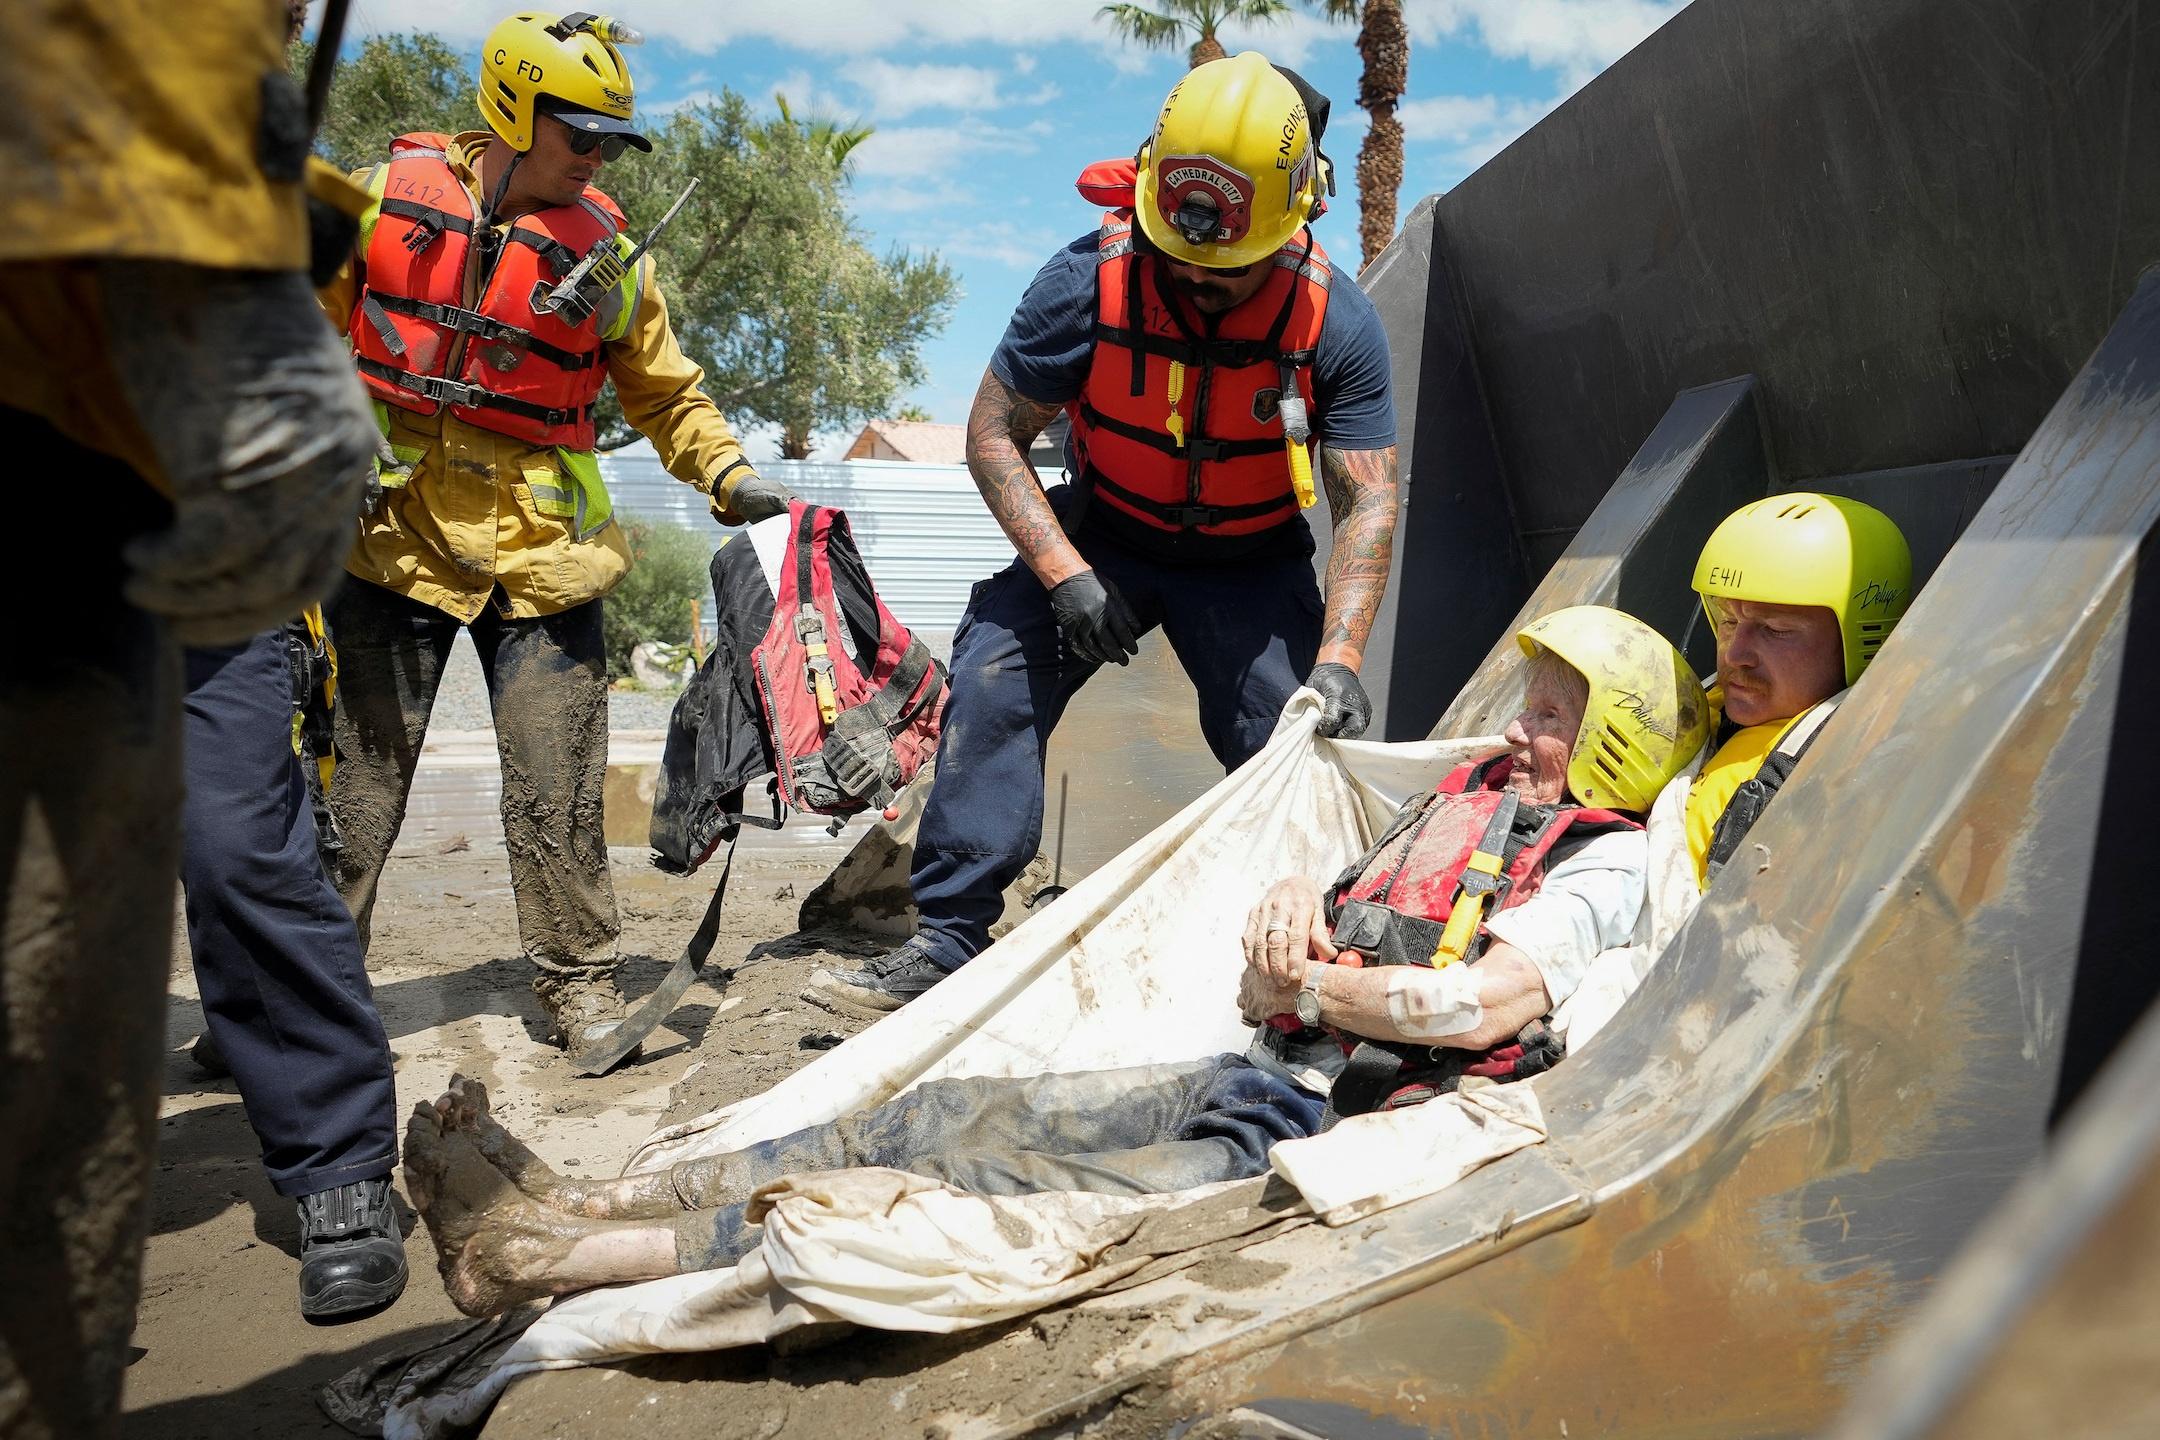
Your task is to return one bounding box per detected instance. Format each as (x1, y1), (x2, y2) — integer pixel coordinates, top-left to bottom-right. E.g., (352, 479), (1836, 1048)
(490, 274), (2160, 1438)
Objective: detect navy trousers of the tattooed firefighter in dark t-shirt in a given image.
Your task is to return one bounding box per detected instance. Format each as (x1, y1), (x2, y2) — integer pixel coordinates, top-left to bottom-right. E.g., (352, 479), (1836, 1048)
(909, 511), (1322, 969)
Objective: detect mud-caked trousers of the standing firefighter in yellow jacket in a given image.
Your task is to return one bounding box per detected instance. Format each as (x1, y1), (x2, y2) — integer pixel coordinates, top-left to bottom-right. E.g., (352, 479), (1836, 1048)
(326, 576), (620, 995)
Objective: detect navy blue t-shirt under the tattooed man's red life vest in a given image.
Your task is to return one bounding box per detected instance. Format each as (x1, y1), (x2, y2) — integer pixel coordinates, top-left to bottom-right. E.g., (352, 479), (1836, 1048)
(989, 231), (1395, 548)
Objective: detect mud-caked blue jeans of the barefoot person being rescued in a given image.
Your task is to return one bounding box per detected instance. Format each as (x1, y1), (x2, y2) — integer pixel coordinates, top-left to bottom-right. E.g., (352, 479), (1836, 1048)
(674, 1056), (1322, 1269)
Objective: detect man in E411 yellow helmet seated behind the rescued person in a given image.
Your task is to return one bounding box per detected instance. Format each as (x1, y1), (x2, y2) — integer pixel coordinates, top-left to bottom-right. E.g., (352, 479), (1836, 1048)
(1687, 492), (1912, 887)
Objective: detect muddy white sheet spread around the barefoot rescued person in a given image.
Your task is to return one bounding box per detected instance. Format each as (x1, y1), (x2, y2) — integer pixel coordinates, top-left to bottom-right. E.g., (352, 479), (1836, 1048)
(384, 691), (1696, 1438)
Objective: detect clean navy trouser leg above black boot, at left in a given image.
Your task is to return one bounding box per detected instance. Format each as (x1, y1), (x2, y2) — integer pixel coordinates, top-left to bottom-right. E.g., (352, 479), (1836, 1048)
(179, 630), (397, 1196)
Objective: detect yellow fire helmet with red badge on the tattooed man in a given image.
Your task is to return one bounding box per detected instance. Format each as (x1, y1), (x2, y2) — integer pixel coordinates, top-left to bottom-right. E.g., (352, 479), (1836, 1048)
(1132, 50), (1326, 270)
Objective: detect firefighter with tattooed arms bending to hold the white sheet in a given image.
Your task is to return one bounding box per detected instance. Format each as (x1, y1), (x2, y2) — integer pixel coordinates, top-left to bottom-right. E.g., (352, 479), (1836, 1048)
(810, 52), (1395, 1013)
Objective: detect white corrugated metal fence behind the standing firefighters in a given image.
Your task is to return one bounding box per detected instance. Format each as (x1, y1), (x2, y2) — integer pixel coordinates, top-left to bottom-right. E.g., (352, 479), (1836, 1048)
(600, 447), (1013, 635)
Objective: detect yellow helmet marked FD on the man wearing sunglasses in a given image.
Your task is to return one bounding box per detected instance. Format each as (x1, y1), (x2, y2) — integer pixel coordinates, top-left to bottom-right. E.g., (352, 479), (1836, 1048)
(480, 11), (652, 151)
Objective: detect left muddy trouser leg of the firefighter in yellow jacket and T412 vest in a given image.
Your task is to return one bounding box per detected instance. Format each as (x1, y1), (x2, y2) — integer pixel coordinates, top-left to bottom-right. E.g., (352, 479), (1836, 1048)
(324, 576), (458, 950)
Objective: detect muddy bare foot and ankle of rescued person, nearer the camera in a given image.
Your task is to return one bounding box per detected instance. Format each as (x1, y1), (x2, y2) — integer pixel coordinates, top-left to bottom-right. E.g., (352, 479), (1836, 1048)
(404, 1105), (676, 1315)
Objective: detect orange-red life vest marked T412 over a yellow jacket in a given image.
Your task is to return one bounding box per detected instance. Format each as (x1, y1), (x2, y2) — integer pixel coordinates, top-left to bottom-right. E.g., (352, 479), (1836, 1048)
(348, 134), (624, 451)
